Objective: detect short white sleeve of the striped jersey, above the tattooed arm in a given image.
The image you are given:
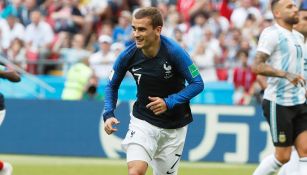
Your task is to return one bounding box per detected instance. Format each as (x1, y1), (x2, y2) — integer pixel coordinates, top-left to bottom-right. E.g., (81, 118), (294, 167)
(257, 27), (278, 55)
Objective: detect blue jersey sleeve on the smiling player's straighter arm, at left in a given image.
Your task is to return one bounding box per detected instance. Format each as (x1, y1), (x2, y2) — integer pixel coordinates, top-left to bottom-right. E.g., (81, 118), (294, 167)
(102, 45), (135, 121)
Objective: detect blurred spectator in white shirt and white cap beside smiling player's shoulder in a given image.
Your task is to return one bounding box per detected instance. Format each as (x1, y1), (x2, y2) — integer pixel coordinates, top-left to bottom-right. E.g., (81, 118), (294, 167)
(89, 35), (115, 79)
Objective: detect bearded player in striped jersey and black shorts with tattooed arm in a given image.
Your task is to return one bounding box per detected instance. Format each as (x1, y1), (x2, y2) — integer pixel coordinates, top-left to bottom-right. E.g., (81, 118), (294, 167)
(252, 0), (307, 175)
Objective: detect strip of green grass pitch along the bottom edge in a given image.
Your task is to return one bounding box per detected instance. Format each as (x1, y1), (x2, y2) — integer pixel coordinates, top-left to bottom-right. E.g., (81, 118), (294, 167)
(0, 155), (256, 175)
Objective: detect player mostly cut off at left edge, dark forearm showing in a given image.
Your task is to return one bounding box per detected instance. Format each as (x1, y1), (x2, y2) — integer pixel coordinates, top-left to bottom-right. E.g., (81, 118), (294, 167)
(0, 65), (20, 175)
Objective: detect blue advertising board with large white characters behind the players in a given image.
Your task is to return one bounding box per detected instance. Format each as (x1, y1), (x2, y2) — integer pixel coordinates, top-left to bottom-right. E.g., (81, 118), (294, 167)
(0, 99), (272, 163)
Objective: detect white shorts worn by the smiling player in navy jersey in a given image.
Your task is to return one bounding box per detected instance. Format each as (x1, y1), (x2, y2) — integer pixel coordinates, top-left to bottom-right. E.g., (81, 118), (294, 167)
(122, 114), (188, 175)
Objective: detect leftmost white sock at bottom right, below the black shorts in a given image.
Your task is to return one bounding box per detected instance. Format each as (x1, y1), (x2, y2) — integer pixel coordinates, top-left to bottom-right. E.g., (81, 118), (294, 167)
(253, 154), (282, 175)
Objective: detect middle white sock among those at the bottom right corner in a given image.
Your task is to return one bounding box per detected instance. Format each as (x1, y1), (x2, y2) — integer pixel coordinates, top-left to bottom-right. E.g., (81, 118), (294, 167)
(278, 150), (299, 175)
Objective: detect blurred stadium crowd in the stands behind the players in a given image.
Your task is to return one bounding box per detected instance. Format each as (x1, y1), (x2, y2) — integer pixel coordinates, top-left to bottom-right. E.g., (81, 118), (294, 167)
(0, 0), (304, 104)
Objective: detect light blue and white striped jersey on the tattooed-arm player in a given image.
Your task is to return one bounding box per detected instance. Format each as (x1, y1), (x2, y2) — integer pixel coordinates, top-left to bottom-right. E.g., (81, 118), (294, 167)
(257, 24), (306, 106)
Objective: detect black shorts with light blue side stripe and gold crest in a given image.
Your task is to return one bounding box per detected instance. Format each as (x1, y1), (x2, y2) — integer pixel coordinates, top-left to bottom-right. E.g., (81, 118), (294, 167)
(262, 100), (307, 147)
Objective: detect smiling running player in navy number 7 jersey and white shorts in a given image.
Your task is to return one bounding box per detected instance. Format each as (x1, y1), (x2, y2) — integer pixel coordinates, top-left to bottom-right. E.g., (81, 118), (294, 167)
(103, 7), (204, 175)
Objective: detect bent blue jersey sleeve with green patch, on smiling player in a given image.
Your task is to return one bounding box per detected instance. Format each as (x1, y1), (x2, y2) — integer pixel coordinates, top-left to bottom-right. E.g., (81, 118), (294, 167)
(164, 43), (204, 109)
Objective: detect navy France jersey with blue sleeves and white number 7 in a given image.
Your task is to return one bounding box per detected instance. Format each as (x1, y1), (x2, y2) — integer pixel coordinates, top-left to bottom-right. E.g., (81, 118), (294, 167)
(103, 36), (204, 129)
